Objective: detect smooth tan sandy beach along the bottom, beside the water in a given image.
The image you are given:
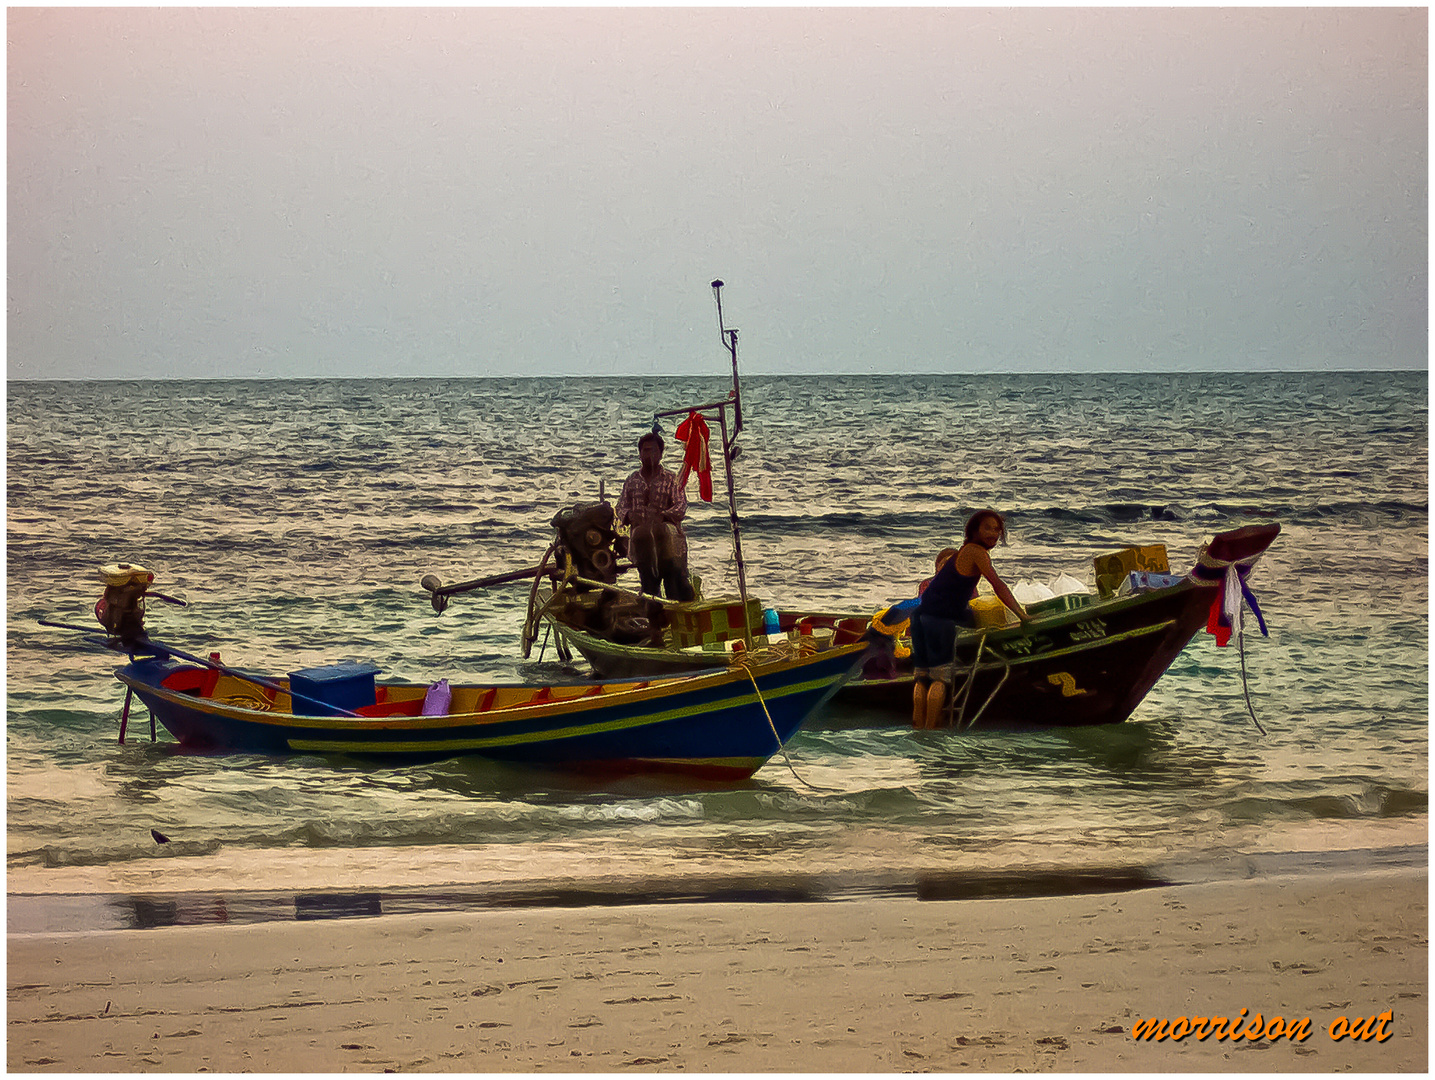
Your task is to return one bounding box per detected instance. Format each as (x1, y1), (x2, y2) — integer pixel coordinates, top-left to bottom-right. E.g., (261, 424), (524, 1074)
(7, 868), (1428, 1073)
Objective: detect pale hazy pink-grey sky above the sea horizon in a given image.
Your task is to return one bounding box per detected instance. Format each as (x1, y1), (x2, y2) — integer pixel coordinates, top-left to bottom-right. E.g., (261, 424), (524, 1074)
(7, 7), (1429, 379)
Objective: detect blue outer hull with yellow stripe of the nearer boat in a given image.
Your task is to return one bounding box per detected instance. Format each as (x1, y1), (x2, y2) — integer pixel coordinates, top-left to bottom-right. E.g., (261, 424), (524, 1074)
(115, 645), (864, 779)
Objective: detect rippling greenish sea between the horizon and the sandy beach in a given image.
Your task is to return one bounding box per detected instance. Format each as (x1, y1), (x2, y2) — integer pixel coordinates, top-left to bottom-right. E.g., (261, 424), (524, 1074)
(6, 371), (1429, 932)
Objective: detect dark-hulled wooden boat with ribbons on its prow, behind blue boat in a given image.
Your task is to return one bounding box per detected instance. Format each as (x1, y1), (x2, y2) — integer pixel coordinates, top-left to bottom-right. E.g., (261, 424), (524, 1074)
(519, 525), (1280, 727)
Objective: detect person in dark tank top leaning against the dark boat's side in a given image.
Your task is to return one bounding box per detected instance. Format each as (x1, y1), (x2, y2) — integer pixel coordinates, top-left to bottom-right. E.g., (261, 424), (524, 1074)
(911, 509), (1030, 729)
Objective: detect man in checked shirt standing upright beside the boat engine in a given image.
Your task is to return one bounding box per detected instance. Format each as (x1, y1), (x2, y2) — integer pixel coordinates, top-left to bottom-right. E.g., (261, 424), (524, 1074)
(617, 432), (693, 601)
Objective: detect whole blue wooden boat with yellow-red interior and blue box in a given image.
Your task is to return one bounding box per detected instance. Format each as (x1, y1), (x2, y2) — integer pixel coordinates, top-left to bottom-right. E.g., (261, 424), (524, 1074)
(101, 631), (865, 780)
